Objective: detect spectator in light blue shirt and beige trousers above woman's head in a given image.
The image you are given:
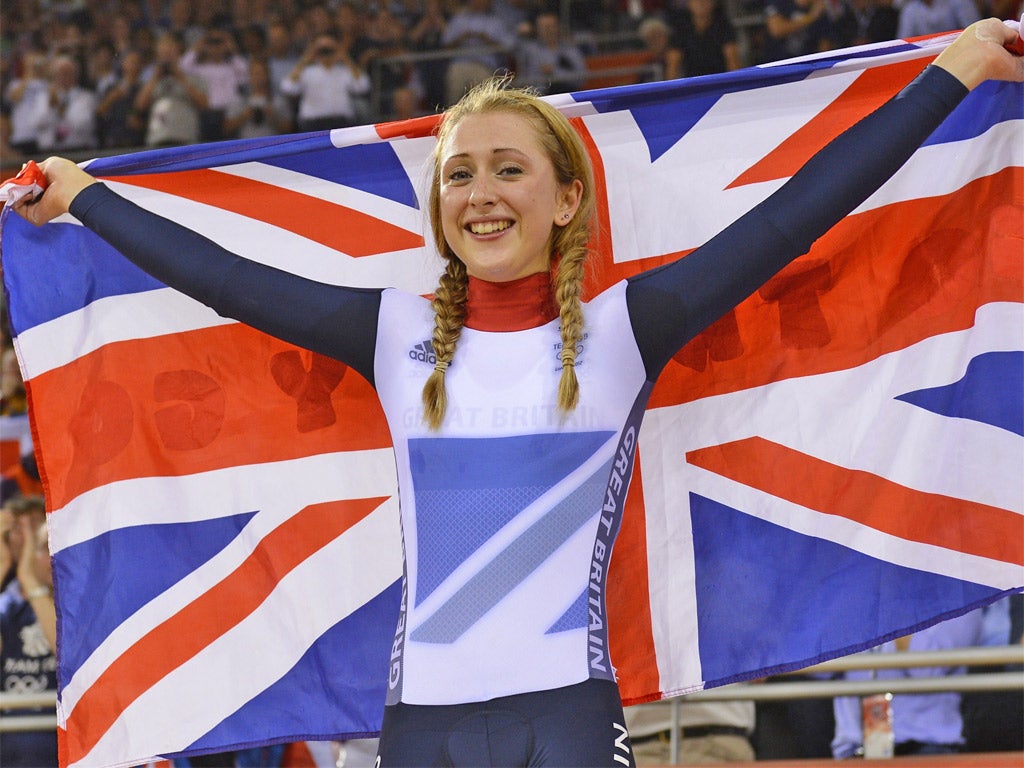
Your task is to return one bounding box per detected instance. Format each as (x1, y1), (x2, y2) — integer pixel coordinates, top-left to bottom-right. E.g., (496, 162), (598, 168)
(441, 0), (515, 104)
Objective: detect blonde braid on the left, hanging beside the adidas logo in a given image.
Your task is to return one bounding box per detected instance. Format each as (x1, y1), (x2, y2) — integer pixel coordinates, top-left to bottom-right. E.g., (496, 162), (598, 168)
(423, 259), (469, 429)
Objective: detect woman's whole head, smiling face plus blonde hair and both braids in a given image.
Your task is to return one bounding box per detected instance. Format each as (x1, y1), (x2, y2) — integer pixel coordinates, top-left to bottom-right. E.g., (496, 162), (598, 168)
(423, 80), (595, 436)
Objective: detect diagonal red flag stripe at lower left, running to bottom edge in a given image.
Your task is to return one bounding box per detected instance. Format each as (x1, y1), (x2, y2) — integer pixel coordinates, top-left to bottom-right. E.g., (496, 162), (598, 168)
(61, 499), (386, 765)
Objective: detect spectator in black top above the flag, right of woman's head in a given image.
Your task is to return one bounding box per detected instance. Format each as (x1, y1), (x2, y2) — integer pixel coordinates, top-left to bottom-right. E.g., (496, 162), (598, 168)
(667, 0), (740, 77)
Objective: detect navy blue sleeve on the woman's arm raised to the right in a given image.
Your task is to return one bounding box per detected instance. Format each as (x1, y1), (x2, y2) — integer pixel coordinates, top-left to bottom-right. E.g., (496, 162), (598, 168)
(626, 67), (968, 381)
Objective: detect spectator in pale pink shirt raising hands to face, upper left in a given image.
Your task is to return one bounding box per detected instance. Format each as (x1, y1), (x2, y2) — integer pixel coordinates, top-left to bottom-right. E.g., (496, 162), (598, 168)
(180, 29), (249, 141)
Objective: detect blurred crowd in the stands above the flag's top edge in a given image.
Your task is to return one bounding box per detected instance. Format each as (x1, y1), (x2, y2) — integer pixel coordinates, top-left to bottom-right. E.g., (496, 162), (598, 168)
(0, 0), (1021, 163)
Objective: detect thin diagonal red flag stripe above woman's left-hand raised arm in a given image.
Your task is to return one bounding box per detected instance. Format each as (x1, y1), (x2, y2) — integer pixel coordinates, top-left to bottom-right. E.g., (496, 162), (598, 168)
(103, 170), (423, 257)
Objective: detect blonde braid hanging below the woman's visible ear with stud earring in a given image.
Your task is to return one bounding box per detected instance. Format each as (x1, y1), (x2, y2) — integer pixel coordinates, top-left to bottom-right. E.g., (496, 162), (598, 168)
(553, 227), (588, 414)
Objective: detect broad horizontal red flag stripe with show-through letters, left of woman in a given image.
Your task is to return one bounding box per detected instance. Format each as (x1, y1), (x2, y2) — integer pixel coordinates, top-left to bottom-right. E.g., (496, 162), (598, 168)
(27, 324), (391, 509)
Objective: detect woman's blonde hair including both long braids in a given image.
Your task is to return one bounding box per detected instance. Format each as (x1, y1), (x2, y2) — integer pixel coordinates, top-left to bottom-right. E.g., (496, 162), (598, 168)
(423, 77), (595, 429)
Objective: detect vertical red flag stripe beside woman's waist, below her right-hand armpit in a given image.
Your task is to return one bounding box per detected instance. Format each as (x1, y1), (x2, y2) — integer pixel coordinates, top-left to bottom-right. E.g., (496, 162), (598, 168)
(606, 447), (662, 705)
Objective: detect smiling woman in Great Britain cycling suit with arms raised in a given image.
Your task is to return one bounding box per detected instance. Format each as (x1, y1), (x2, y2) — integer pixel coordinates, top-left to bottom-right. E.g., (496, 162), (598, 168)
(18, 19), (1024, 766)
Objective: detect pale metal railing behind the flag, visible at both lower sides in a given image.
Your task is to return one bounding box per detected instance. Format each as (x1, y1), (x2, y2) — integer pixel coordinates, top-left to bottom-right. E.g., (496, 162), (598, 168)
(0, 645), (1024, 763)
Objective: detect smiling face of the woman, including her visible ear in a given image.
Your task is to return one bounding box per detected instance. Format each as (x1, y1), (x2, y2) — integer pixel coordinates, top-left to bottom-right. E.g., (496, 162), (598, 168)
(440, 112), (583, 283)
